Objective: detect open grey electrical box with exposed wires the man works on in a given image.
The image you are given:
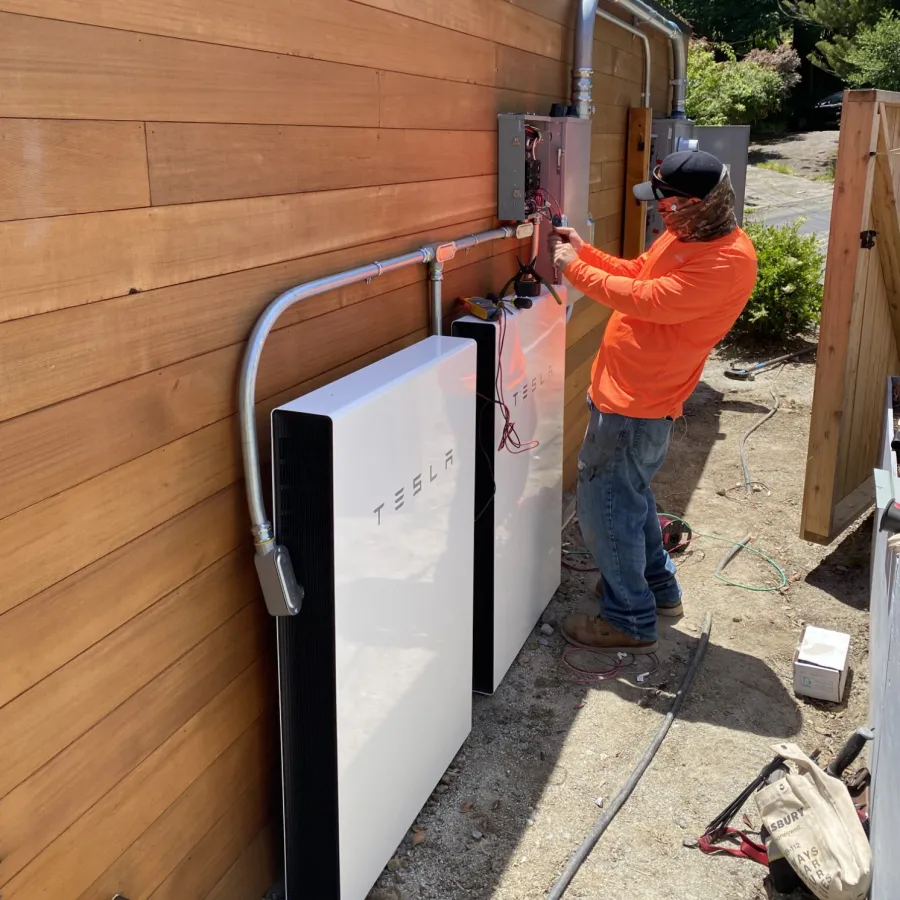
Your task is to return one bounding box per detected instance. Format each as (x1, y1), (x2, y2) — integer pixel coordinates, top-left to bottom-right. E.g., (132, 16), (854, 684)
(497, 113), (591, 288)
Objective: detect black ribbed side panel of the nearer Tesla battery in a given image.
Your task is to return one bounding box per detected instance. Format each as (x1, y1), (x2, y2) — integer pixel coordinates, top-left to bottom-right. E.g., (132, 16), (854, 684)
(272, 411), (341, 900)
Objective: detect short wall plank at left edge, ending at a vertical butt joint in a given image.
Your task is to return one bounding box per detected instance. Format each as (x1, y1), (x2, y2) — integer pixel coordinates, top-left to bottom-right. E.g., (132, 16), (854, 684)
(0, 119), (150, 221)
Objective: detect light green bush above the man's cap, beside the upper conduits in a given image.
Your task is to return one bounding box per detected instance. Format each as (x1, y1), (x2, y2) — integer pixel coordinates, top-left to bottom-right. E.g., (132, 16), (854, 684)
(686, 41), (784, 125)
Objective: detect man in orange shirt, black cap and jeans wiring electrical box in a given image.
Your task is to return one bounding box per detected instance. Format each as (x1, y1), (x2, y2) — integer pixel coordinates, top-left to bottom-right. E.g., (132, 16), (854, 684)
(550, 151), (756, 653)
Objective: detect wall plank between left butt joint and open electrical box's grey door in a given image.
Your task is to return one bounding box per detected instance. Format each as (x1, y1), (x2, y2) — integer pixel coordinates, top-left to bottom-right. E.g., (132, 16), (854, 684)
(147, 122), (497, 206)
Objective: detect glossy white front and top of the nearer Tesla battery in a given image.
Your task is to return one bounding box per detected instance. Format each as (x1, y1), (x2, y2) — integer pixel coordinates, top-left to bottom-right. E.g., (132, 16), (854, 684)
(274, 337), (475, 900)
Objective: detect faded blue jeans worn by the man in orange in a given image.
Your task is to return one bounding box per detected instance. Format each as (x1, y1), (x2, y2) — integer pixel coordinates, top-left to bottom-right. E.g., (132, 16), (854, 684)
(578, 403), (681, 641)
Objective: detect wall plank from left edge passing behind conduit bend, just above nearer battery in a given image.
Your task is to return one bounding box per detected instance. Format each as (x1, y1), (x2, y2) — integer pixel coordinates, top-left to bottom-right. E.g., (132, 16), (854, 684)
(0, 250), (502, 515)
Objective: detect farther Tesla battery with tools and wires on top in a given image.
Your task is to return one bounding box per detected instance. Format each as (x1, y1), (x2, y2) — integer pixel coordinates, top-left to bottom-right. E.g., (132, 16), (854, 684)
(453, 287), (566, 694)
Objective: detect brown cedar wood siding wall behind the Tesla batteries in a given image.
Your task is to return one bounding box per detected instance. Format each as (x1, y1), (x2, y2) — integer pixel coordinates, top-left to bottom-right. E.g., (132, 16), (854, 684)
(0, 0), (669, 900)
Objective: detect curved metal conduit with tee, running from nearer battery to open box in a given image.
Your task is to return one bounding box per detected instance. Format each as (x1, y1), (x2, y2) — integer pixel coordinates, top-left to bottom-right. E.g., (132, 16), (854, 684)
(238, 216), (538, 616)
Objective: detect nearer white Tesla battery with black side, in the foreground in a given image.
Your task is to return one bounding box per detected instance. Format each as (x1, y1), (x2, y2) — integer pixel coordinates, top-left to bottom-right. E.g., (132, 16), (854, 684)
(272, 337), (476, 900)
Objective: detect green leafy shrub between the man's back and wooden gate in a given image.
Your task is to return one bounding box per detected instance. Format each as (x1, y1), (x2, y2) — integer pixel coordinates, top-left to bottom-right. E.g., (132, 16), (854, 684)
(734, 219), (824, 340)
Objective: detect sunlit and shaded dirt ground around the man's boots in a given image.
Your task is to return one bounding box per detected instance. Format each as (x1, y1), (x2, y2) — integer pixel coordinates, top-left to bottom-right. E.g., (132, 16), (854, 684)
(371, 351), (871, 900)
